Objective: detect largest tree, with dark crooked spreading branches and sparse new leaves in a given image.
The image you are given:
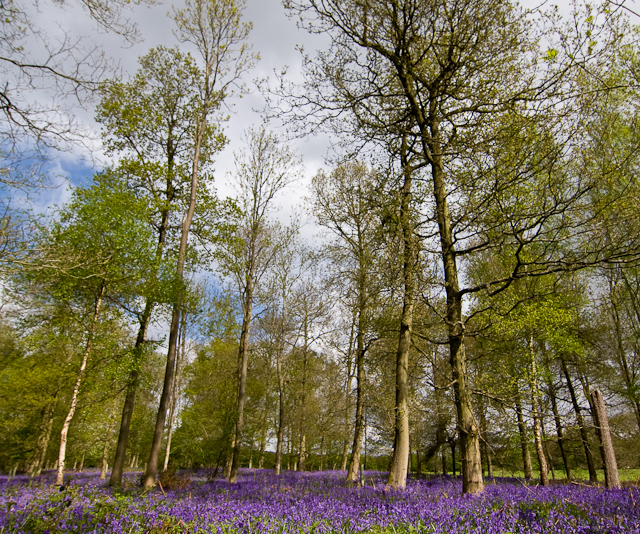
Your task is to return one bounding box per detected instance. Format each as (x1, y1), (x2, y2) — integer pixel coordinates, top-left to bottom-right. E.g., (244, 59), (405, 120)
(286, 0), (632, 493)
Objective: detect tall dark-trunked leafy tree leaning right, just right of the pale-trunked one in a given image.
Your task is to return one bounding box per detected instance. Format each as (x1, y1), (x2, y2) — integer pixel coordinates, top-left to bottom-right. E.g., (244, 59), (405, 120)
(97, 47), (214, 486)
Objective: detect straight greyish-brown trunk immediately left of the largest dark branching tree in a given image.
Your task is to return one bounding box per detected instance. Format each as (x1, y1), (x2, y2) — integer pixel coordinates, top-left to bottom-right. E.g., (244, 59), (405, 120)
(387, 141), (416, 488)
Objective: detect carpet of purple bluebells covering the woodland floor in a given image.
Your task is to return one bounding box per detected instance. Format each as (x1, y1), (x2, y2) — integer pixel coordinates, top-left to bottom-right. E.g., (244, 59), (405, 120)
(0, 470), (640, 534)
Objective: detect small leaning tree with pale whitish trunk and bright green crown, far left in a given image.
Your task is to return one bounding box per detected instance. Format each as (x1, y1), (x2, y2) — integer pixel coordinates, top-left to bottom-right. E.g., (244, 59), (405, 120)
(19, 174), (154, 484)
